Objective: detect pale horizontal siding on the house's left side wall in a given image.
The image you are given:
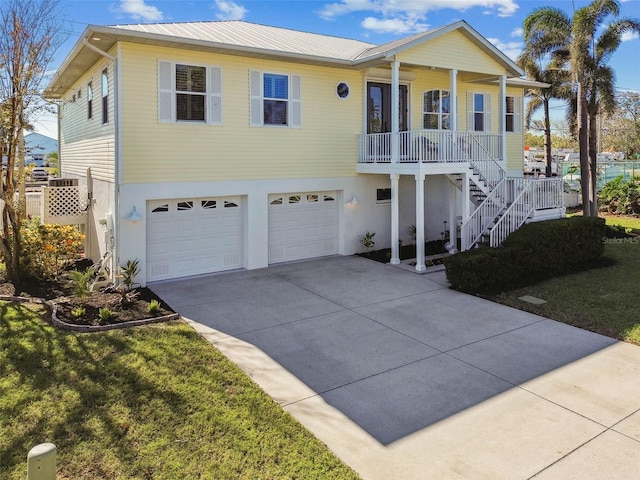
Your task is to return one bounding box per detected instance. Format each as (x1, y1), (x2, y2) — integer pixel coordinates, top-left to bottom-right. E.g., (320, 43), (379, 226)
(60, 56), (115, 182)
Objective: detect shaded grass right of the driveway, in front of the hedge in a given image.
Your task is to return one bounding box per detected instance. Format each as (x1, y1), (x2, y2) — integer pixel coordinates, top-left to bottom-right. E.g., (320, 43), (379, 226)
(491, 242), (640, 345)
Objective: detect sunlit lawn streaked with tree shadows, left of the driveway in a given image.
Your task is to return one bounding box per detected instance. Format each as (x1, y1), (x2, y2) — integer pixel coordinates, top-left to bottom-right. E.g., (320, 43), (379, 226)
(0, 302), (358, 480)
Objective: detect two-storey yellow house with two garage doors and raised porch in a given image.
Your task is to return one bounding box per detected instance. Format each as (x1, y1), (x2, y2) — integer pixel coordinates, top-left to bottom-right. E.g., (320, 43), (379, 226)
(46, 21), (563, 285)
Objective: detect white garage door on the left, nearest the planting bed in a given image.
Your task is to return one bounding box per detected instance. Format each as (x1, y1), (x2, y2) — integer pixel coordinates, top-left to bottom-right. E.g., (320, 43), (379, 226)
(147, 197), (244, 281)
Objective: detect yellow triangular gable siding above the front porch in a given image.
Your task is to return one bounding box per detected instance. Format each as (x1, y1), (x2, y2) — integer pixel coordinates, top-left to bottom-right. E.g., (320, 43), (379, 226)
(397, 30), (505, 75)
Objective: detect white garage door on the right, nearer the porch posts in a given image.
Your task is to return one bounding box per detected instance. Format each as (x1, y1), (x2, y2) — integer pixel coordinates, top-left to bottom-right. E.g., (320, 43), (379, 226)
(269, 192), (338, 263)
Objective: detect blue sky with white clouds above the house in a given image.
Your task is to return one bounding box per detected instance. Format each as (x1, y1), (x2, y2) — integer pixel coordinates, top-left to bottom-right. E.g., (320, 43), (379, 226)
(33, 0), (640, 138)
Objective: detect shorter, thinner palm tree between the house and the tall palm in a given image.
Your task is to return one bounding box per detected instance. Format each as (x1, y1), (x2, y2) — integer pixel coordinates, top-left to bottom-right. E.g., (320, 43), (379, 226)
(518, 50), (572, 177)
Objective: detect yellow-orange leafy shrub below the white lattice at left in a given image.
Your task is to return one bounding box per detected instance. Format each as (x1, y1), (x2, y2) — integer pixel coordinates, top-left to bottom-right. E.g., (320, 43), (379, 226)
(20, 219), (84, 280)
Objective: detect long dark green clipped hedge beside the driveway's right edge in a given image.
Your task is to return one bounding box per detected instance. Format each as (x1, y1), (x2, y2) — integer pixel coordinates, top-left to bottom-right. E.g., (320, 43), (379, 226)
(445, 216), (607, 293)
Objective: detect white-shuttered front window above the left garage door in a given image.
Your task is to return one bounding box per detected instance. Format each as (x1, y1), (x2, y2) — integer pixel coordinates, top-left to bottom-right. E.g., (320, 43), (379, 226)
(158, 61), (222, 125)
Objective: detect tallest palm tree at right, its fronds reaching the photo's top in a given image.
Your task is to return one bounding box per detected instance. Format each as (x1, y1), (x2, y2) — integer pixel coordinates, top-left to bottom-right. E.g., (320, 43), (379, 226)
(523, 0), (640, 216)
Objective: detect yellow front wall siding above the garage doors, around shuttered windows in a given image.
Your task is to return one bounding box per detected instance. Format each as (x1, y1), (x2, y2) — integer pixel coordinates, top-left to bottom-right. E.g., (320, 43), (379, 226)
(121, 44), (364, 183)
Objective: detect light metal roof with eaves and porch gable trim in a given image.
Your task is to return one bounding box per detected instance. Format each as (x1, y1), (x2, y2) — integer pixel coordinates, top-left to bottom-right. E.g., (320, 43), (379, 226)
(45, 20), (524, 98)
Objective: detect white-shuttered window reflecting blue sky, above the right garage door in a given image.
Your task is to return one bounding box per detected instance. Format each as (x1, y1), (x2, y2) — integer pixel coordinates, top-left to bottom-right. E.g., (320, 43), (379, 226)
(249, 70), (301, 127)
